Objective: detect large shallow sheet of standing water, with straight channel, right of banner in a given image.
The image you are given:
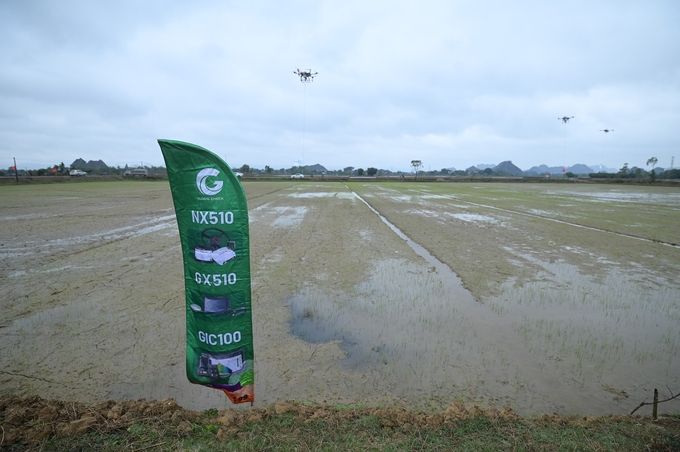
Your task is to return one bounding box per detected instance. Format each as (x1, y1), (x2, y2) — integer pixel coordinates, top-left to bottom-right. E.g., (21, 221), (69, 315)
(288, 185), (680, 414)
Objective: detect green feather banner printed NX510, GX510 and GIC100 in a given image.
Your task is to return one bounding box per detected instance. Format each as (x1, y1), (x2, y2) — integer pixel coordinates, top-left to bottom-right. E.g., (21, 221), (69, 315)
(158, 140), (255, 403)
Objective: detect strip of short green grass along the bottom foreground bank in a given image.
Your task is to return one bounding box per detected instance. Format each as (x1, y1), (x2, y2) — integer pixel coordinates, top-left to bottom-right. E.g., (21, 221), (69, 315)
(18, 413), (680, 452)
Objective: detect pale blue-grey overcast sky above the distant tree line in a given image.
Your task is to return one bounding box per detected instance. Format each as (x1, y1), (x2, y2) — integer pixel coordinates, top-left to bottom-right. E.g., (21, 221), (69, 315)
(0, 0), (680, 170)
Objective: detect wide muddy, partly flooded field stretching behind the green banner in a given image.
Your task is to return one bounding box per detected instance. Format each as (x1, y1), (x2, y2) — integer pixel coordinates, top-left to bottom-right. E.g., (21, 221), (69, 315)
(0, 181), (680, 414)
